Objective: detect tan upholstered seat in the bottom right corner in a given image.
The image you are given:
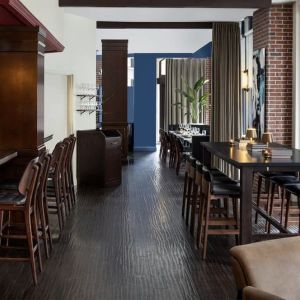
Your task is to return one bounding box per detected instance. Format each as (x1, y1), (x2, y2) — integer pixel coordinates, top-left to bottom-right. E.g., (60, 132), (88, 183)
(230, 237), (300, 300)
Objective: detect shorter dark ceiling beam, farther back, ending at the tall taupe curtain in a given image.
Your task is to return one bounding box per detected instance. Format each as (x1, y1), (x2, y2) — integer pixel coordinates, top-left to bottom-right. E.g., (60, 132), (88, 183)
(97, 21), (213, 29)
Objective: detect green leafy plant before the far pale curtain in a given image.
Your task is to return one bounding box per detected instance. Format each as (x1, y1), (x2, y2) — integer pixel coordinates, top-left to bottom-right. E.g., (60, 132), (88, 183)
(174, 77), (210, 123)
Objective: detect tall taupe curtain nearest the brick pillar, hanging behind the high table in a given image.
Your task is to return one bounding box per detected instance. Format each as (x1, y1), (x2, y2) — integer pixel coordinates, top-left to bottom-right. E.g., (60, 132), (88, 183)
(211, 23), (241, 178)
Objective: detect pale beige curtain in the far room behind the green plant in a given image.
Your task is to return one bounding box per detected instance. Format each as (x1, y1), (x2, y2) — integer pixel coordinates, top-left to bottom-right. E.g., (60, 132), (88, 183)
(164, 58), (205, 129)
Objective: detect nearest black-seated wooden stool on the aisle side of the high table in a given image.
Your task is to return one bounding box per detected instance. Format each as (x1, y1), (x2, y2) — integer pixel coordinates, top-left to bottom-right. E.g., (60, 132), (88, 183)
(199, 172), (240, 259)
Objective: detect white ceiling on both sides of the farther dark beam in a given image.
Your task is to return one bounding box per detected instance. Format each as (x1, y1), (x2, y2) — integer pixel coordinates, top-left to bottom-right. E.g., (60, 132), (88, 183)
(65, 0), (286, 53)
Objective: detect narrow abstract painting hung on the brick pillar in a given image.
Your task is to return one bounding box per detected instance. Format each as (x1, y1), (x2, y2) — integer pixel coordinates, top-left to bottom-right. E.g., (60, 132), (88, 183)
(251, 48), (266, 138)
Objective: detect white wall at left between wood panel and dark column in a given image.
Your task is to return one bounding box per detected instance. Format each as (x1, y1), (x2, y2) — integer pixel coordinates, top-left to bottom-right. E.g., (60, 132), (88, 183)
(21, 0), (96, 142)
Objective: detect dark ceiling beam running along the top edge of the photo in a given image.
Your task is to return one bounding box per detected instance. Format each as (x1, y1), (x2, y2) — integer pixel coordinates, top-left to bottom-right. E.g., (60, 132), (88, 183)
(59, 0), (272, 8)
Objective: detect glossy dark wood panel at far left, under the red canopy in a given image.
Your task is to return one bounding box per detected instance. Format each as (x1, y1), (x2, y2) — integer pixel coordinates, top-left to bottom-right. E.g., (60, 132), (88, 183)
(0, 27), (45, 151)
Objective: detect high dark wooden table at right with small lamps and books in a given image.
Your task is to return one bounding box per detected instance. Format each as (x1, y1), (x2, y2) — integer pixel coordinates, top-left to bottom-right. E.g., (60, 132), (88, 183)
(201, 142), (300, 244)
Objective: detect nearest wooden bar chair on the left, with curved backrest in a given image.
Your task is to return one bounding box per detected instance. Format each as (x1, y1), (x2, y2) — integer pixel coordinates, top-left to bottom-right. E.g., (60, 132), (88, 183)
(0, 159), (42, 285)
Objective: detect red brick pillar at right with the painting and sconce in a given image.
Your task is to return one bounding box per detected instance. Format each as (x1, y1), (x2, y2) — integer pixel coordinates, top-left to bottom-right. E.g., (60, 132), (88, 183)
(253, 4), (293, 145)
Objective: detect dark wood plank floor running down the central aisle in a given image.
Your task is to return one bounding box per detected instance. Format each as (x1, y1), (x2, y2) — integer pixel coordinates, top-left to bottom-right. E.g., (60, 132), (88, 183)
(0, 153), (236, 300)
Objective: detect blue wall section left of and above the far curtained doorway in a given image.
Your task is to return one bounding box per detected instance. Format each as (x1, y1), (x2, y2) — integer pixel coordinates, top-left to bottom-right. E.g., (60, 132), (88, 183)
(134, 53), (191, 151)
